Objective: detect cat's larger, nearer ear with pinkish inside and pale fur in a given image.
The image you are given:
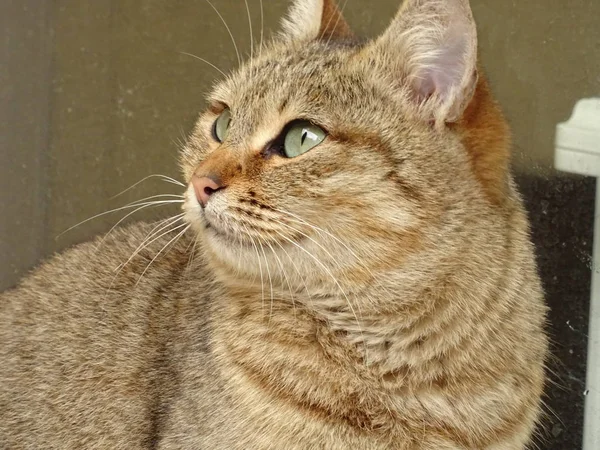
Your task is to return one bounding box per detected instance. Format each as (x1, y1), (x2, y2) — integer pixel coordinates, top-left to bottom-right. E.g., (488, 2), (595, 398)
(370, 0), (477, 126)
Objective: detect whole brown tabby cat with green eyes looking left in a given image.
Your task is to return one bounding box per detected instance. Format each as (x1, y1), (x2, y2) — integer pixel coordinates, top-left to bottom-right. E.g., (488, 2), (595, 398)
(0, 0), (547, 450)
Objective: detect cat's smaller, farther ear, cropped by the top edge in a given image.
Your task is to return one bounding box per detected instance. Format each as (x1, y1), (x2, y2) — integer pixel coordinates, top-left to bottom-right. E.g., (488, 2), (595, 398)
(282, 0), (352, 41)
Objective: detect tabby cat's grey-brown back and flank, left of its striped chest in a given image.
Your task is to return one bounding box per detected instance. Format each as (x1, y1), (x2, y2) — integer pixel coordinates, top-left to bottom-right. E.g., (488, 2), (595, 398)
(0, 224), (225, 449)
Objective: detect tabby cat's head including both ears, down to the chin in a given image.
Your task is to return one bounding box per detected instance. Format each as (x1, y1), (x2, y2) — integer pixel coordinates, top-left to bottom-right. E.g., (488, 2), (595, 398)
(182, 0), (508, 302)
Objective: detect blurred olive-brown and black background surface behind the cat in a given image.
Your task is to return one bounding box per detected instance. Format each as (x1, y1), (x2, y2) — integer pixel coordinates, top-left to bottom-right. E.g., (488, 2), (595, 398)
(0, 0), (600, 450)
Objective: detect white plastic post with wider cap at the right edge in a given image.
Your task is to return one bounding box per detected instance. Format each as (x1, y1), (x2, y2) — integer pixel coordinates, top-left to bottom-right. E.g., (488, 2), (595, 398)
(554, 98), (600, 450)
